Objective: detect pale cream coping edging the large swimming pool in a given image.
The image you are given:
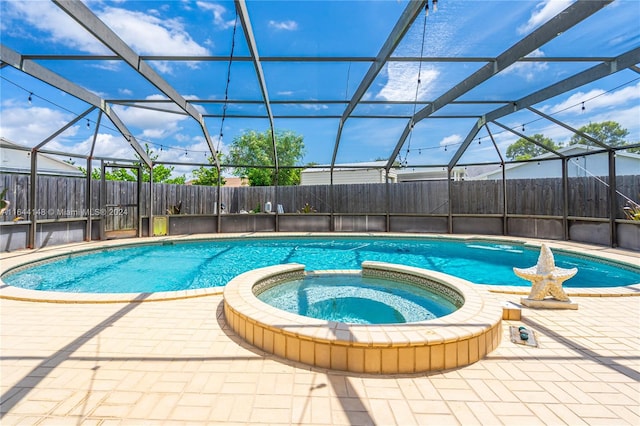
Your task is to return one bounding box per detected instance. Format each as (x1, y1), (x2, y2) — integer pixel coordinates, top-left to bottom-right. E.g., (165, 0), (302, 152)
(0, 232), (640, 303)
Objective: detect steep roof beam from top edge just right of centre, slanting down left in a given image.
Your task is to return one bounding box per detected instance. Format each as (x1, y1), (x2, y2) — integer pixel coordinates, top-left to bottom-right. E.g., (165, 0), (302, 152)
(331, 0), (426, 170)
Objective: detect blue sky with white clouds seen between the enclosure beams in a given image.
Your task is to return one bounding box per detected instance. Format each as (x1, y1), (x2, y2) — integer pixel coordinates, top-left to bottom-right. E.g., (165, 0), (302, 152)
(0, 0), (640, 178)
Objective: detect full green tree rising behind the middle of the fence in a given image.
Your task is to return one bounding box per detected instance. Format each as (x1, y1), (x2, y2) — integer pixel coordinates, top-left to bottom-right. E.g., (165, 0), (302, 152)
(229, 130), (304, 186)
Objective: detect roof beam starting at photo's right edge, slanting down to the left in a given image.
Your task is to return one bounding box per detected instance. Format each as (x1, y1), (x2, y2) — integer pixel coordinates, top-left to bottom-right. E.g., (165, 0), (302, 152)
(451, 41), (640, 171)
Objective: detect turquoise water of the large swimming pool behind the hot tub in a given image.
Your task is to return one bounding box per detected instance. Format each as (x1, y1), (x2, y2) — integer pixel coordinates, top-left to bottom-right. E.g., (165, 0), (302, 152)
(2, 237), (640, 293)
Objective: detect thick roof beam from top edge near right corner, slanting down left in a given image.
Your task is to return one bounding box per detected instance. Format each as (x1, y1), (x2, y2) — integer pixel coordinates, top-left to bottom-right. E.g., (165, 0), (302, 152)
(386, 0), (613, 170)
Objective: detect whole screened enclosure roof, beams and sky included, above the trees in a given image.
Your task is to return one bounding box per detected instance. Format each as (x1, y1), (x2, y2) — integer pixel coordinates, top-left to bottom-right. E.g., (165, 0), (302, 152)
(0, 0), (640, 176)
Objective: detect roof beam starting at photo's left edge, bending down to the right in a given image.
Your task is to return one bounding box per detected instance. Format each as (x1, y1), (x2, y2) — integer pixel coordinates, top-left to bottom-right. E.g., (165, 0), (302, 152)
(0, 44), (151, 167)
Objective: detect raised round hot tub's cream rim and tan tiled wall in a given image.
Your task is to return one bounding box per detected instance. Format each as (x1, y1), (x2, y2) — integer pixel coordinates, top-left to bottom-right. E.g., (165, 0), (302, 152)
(224, 262), (502, 374)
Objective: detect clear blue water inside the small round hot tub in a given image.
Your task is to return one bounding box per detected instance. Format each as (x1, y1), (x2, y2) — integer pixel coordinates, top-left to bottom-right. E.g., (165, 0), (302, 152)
(256, 274), (457, 324)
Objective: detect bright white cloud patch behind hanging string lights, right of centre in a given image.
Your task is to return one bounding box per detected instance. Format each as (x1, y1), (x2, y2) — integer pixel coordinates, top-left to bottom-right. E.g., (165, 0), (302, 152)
(376, 62), (440, 101)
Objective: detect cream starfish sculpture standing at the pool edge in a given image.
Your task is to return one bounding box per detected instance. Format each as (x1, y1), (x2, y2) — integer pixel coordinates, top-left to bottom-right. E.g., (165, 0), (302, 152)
(513, 244), (578, 302)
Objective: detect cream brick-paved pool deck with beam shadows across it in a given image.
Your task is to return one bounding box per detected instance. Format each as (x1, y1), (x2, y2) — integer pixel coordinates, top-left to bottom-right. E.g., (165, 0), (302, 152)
(0, 234), (640, 425)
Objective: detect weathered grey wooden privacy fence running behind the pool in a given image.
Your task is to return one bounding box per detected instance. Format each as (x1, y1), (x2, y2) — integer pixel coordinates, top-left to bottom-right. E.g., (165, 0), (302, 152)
(0, 174), (640, 223)
